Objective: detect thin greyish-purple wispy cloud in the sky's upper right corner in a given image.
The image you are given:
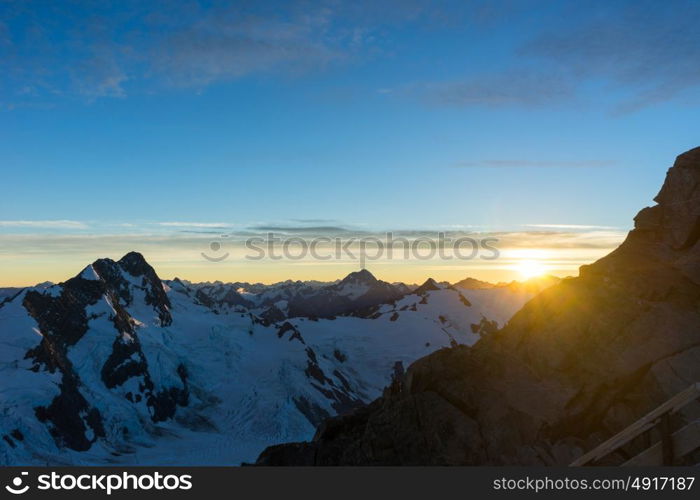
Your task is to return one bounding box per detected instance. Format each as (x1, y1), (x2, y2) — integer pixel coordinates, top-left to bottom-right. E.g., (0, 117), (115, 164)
(521, 0), (700, 112)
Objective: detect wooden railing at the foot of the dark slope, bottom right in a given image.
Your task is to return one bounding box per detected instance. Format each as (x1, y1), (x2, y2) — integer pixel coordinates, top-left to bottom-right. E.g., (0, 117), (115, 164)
(571, 383), (700, 466)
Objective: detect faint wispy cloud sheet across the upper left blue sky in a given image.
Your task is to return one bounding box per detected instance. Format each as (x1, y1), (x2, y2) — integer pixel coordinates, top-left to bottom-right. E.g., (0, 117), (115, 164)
(0, 0), (435, 100)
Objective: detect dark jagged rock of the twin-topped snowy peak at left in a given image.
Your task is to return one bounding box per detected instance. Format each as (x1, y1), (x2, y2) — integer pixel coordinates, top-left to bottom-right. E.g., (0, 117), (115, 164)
(22, 252), (188, 451)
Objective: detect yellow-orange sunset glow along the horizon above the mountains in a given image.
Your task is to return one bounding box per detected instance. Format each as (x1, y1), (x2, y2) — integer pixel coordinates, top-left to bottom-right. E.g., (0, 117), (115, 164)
(0, 235), (623, 287)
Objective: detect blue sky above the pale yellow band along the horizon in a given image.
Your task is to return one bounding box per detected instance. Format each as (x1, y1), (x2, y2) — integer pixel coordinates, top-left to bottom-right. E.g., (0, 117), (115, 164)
(0, 0), (700, 282)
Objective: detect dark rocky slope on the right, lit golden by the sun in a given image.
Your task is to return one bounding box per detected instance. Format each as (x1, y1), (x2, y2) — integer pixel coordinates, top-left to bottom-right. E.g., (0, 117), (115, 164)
(258, 148), (700, 465)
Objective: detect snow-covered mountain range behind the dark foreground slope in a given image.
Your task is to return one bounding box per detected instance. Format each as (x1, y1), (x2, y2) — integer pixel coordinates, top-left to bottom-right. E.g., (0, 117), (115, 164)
(0, 252), (549, 465)
